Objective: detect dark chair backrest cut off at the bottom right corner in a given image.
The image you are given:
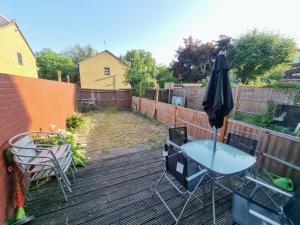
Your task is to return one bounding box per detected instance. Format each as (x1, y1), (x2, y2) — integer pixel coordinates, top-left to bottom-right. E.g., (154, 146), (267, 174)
(283, 188), (300, 225)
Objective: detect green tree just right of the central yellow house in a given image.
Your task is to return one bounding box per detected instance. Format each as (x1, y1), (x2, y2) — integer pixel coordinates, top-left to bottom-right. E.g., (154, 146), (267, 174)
(122, 49), (156, 96)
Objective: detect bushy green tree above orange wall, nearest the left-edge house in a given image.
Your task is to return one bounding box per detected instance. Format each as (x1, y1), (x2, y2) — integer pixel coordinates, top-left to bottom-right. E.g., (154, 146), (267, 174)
(36, 48), (74, 80)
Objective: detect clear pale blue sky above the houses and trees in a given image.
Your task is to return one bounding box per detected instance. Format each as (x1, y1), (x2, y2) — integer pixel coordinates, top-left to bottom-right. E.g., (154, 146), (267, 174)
(0, 0), (300, 64)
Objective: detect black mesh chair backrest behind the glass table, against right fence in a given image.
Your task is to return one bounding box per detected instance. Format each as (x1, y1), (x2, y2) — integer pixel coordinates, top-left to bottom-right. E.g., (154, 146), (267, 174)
(226, 131), (258, 156)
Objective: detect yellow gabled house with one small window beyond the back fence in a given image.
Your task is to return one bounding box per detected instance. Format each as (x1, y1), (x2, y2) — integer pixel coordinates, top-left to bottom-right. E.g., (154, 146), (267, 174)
(79, 50), (130, 90)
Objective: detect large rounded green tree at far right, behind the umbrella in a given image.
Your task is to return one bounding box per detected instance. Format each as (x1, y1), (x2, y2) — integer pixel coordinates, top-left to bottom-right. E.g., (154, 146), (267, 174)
(227, 30), (296, 83)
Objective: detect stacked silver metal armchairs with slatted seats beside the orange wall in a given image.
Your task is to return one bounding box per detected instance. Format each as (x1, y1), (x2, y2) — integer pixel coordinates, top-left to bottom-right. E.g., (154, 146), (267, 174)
(9, 131), (77, 201)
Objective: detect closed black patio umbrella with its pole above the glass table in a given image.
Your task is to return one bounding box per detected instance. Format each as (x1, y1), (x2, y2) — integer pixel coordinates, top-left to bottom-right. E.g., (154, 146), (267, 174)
(202, 52), (233, 151)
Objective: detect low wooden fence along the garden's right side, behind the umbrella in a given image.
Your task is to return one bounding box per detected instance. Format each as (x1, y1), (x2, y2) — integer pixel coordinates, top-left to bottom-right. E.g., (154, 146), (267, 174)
(132, 97), (300, 185)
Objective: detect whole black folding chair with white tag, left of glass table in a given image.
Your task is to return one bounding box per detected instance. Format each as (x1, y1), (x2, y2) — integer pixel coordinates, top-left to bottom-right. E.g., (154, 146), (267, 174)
(150, 140), (207, 224)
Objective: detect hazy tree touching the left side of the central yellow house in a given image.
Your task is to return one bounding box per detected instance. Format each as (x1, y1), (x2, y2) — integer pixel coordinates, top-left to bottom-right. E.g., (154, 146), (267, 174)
(61, 44), (97, 82)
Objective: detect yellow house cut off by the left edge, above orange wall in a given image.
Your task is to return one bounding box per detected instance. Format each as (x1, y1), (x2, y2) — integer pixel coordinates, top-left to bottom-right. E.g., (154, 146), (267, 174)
(0, 13), (38, 78)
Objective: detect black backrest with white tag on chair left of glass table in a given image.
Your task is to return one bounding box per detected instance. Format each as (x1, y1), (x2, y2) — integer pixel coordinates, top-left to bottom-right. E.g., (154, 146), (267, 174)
(165, 142), (200, 190)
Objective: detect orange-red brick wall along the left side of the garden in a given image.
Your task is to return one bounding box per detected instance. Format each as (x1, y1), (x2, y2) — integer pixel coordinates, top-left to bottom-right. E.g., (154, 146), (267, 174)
(0, 74), (76, 224)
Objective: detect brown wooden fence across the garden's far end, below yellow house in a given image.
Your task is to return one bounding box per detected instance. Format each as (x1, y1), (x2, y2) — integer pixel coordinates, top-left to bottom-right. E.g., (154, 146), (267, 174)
(76, 88), (131, 109)
